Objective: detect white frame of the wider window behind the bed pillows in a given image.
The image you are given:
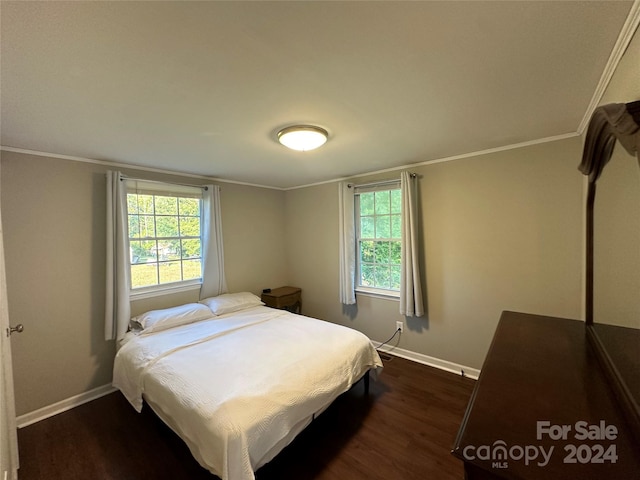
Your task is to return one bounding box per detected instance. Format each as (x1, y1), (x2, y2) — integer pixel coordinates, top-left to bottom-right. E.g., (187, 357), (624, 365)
(126, 180), (204, 300)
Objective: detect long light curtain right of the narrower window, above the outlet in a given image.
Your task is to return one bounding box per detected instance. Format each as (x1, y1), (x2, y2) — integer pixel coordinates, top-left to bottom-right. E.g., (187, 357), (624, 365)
(400, 172), (424, 317)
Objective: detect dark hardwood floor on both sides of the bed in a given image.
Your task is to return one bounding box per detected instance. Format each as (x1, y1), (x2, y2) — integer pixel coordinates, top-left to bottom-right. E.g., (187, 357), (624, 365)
(18, 357), (475, 480)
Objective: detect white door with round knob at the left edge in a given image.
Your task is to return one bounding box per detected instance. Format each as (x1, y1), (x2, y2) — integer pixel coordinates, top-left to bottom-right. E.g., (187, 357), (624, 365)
(0, 172), (19, 480)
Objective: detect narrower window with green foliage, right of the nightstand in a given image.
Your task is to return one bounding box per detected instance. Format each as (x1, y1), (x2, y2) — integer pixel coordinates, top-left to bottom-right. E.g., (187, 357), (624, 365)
(355, 184), (402, 296)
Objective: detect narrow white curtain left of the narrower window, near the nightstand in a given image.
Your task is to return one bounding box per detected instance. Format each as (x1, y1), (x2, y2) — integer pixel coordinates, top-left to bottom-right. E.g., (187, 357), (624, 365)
(338, 182), (356, 305)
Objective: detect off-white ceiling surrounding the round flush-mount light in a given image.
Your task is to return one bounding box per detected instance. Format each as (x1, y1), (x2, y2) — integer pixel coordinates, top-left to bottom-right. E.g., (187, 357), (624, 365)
(0, 1), (632, 188)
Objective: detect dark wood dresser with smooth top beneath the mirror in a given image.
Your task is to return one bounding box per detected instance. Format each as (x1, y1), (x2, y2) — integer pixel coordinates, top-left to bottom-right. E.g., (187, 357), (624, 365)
(452, 312), (640, 480)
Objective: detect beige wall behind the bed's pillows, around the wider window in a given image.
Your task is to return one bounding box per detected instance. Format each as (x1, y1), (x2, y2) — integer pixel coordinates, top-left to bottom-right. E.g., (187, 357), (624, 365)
(1, 151), (286, 415)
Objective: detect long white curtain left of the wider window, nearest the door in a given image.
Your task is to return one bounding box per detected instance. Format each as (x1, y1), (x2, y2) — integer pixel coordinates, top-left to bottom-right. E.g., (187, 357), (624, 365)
(104, 171), (131, 340)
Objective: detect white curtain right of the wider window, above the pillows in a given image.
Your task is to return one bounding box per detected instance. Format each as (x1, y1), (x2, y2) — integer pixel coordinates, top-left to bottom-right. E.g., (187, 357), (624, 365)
(200, 185), (227, 300)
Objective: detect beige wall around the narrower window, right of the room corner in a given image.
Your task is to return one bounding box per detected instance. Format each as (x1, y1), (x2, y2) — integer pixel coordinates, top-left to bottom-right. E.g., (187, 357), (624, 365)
(286, 137), (582, 368)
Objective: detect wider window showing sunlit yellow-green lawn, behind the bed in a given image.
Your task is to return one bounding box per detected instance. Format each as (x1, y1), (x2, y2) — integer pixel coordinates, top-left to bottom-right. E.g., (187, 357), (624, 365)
(127, 182), (202, 294)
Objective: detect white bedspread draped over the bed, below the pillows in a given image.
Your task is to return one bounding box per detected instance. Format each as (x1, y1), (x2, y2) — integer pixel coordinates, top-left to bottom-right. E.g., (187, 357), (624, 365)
(113, 307), (382, 480)
